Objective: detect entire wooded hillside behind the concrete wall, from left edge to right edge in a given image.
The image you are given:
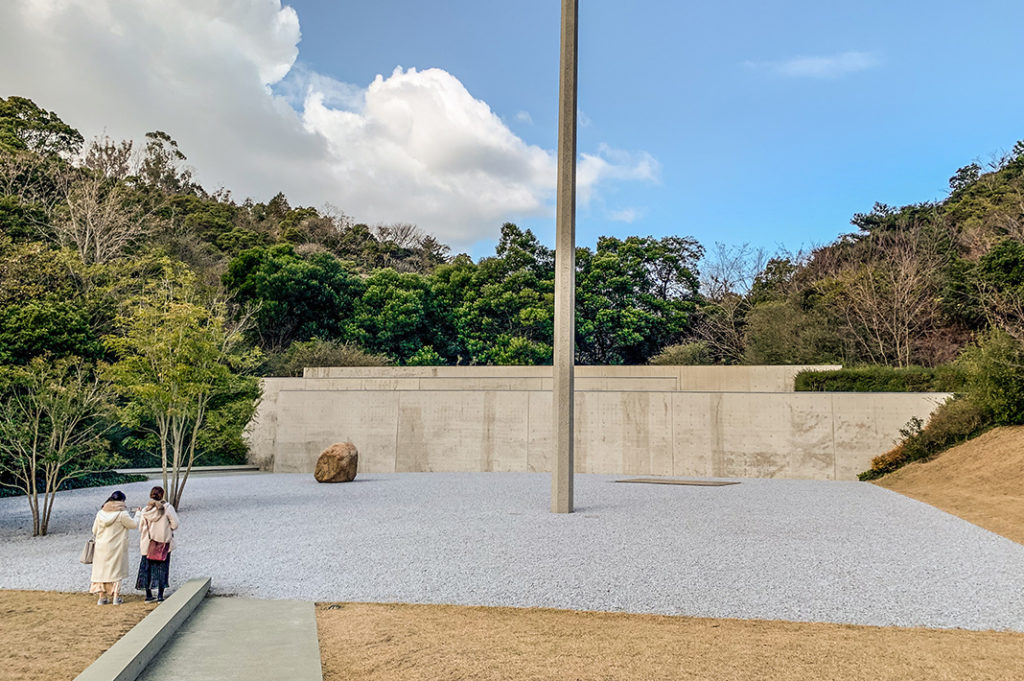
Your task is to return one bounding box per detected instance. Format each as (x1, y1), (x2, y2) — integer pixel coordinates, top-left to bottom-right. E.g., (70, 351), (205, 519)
(0, 96), (1024, 499)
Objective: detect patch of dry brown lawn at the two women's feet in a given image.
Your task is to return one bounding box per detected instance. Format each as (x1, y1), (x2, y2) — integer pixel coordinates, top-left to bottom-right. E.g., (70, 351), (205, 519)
(0, 591), (156, 681)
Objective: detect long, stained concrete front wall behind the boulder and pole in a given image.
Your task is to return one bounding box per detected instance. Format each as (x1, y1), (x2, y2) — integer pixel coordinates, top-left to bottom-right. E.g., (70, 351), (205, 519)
(249, 368), (947, 480)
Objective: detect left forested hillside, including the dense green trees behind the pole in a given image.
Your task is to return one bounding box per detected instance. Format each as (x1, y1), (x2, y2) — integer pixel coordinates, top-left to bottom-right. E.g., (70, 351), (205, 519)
(0, 97), (701, 371)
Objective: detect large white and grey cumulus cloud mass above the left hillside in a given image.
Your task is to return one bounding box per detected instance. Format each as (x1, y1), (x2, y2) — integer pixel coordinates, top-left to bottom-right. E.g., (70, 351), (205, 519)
(0, 0), (659, 248)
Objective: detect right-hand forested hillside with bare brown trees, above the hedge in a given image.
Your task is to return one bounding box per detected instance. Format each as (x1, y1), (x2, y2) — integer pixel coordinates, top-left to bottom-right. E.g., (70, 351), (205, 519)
(689, 142), (1024, 367)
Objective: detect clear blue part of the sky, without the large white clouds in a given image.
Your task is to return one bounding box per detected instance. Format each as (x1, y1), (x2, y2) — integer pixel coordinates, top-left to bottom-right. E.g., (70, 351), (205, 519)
(280, 0), (1024, 254)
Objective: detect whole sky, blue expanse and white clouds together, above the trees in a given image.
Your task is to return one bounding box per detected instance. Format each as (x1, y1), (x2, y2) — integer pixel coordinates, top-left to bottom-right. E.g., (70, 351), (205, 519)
(0, 0), (1024, 257)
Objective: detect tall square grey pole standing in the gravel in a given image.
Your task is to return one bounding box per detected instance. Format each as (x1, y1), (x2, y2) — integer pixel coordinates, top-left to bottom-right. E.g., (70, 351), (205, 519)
(551, 0), (580, 513)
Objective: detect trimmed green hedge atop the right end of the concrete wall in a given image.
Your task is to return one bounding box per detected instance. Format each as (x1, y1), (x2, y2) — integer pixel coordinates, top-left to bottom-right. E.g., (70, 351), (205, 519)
(795, 365), (966, 392)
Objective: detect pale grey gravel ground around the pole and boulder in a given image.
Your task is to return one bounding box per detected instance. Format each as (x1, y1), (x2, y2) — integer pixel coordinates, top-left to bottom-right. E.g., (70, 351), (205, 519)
(0, 473), (1024, 631)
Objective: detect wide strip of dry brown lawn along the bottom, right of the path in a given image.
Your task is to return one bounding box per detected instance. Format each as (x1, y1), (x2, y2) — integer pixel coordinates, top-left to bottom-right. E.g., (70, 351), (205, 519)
(316, 603), (1024, 681)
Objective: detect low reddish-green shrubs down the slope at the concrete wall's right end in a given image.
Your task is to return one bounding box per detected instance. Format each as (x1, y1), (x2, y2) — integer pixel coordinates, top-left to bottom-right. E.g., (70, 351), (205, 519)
(858, 397), (991, 480)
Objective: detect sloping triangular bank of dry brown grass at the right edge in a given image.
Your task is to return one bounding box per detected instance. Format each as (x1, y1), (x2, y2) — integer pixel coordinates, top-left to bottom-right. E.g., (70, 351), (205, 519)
(877, 426), (1024, 544)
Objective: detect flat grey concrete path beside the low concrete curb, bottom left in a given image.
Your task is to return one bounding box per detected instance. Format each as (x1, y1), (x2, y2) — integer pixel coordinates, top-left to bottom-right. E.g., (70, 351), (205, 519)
(138, 597), (324, 681)
